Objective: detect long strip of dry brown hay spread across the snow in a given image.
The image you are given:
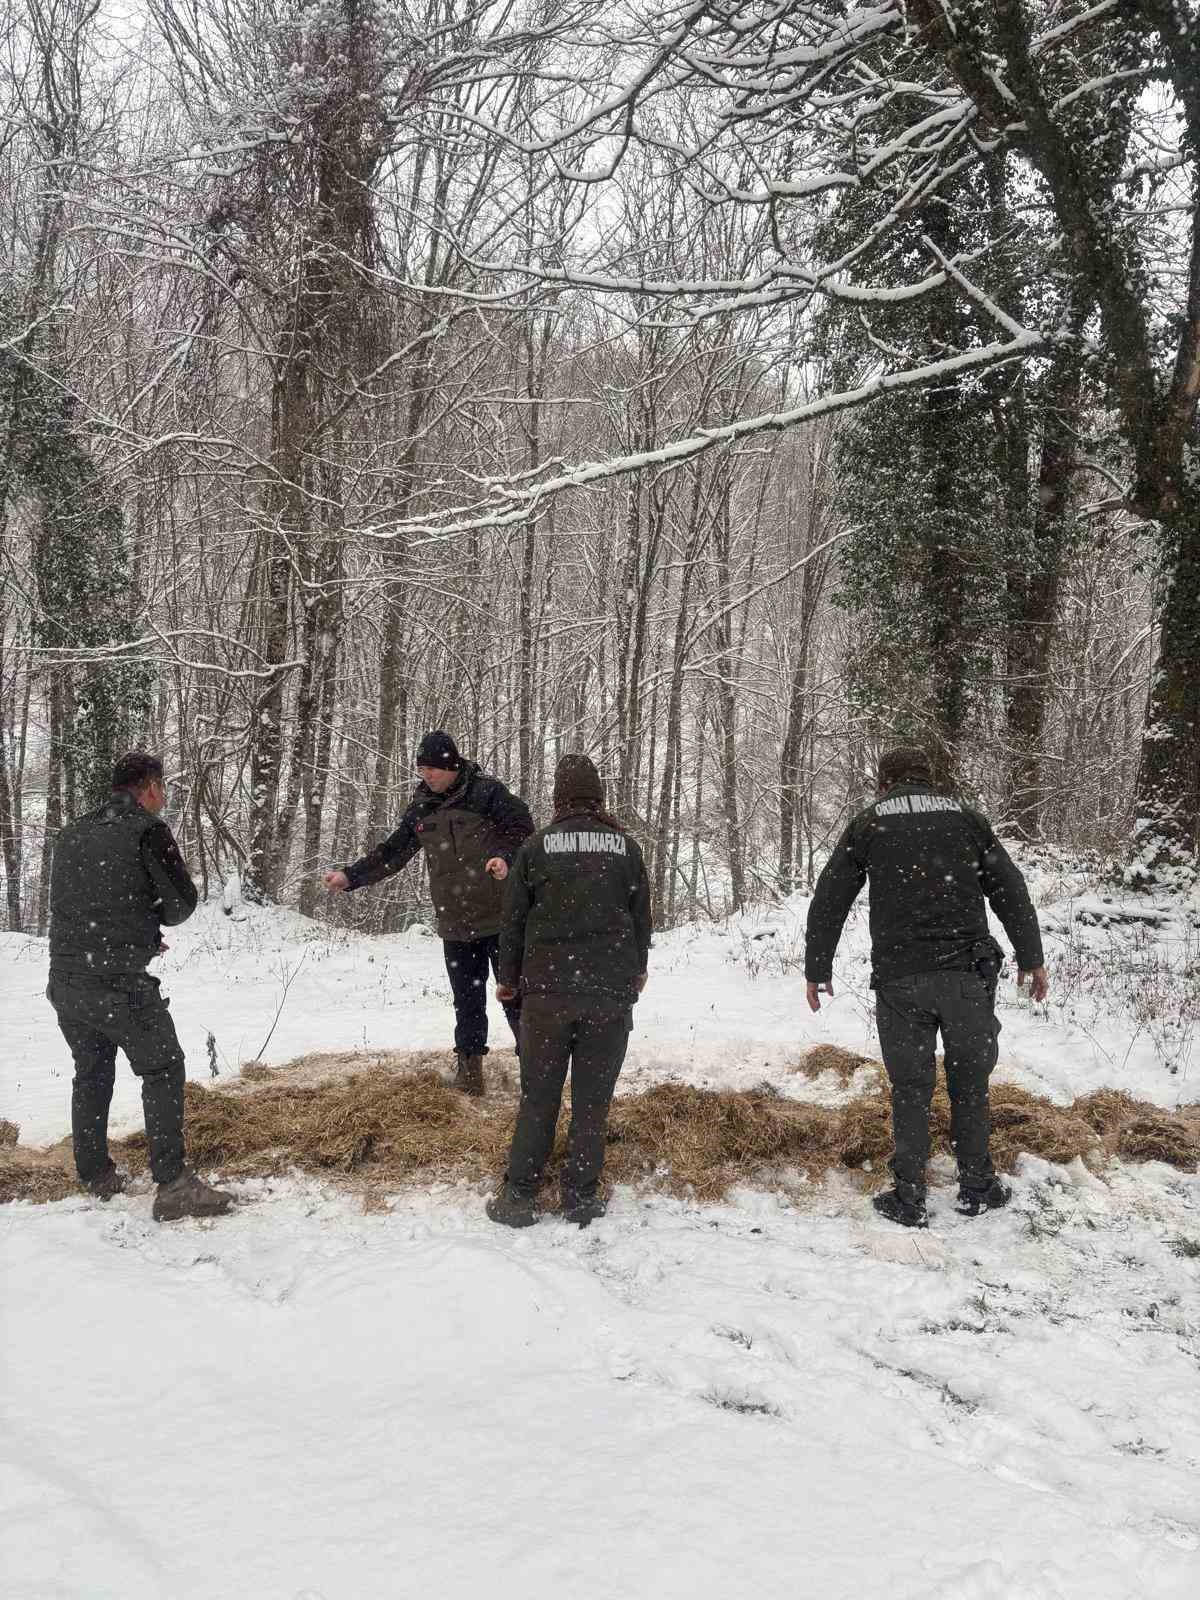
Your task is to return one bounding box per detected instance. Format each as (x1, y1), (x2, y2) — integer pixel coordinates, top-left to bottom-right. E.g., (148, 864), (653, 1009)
(0, 1046), (1200, 1202)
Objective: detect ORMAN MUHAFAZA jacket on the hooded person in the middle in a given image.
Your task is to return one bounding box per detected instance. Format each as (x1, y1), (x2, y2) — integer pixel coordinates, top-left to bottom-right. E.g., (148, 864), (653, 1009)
(499, 811), (651, 1005)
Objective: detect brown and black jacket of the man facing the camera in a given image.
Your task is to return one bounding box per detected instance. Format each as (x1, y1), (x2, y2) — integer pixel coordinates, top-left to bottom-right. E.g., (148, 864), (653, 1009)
(342, 762), (533, 939)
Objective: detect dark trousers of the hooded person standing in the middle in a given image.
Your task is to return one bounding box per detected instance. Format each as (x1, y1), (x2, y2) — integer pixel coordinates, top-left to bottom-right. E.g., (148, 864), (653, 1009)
(507, 995), (632, 1206)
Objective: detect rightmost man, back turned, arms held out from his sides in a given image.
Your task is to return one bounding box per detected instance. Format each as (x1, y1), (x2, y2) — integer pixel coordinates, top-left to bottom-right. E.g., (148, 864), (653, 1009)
(805, 749), (1048, 1227)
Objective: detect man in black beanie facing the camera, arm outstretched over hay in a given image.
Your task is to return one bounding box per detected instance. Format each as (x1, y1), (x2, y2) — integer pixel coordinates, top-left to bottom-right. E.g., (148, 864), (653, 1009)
(325, 728), (533, 1094)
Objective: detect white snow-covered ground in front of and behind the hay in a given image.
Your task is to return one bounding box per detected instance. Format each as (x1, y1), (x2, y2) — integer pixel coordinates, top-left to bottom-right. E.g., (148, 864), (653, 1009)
(0, 885), (1200, 1600)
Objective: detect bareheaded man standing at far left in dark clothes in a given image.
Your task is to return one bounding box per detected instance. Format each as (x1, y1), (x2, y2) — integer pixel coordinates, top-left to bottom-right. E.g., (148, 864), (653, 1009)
(46, 752), (234, 1222)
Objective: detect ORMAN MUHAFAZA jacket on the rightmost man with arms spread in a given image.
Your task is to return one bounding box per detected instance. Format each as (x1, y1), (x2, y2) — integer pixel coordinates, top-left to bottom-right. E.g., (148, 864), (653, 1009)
(805, 784), (1043, 984)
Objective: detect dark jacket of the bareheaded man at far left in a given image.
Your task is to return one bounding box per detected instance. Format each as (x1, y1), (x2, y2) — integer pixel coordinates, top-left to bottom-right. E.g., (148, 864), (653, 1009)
(50, 789), (197, 978)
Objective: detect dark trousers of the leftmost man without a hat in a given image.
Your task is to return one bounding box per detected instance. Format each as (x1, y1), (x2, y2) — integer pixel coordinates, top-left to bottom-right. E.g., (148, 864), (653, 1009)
(46, 973), (184, 1184)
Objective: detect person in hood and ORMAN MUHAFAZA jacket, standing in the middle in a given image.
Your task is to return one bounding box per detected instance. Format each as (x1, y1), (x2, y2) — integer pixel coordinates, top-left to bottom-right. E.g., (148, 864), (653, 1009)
(488, 755), (651, 1227)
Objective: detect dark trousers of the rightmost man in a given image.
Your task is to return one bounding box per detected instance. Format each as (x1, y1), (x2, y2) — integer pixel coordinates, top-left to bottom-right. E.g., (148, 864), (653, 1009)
(875, 963), (1000, 1198)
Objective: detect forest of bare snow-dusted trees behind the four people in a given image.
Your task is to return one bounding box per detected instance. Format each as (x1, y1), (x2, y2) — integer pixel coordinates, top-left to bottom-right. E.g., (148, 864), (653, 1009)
(0, 0), (1200, 931)
